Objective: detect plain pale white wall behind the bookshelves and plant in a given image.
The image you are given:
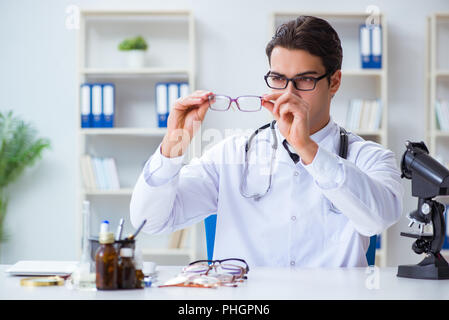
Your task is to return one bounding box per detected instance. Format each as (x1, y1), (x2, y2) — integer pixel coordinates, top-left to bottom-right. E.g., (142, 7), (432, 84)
(0, 0), (449, 266)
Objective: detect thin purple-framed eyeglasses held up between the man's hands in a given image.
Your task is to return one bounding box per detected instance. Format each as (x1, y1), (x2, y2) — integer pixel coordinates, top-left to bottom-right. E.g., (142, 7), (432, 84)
(209, 94), (262, 112)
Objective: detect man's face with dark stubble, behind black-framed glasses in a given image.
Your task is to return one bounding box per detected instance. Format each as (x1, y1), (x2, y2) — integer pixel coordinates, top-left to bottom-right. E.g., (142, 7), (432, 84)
(270, 46), (341, 134)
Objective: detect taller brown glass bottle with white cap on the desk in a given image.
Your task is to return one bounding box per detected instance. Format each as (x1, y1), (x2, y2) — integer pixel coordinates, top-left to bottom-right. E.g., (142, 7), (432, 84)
(95, 221), (118, 290)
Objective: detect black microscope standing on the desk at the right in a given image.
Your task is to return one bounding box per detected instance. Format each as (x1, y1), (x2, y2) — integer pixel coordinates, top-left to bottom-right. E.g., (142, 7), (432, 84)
(397, 141), (449, 279)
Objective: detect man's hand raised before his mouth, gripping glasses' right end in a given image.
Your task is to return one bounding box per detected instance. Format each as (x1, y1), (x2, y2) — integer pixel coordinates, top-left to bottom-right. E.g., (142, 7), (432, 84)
(262, 92), (318, 165)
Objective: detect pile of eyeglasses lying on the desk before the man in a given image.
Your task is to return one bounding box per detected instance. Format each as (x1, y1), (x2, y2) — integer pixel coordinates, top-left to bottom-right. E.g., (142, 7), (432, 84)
(159, 258), (249, 288)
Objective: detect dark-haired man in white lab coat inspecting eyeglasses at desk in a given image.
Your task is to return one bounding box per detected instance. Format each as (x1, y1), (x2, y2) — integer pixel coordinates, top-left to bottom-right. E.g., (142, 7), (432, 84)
(130, 16), (403, 267)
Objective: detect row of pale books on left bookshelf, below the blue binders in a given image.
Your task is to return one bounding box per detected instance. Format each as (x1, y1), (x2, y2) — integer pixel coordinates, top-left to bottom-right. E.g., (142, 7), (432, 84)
(81, 154), (120, 190)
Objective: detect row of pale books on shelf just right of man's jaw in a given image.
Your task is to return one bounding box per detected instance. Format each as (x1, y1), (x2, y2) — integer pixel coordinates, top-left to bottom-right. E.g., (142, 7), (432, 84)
(345, 99), (382, 131)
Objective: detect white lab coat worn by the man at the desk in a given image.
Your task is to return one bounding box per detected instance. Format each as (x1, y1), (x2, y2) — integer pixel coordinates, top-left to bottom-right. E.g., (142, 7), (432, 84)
(130, 119), (403, 267)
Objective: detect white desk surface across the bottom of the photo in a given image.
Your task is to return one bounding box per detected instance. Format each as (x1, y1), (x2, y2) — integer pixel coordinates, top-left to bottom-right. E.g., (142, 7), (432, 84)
(0, 265), (449, 300)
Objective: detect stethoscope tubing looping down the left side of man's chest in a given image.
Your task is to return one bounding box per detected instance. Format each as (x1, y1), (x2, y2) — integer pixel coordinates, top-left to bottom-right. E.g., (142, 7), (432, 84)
(240, 120), (278, 201)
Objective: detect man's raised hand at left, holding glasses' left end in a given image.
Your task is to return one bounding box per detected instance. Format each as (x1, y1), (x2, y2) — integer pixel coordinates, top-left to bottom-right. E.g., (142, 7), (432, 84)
(161, 90), (213, 158)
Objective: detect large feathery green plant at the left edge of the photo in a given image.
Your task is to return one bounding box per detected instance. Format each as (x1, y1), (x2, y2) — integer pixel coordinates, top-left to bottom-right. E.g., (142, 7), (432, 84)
(0, 111), (50, 249)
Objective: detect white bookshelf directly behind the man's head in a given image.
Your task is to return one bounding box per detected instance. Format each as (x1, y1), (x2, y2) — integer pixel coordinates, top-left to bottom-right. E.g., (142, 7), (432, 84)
(269, 11), (388, 266)
